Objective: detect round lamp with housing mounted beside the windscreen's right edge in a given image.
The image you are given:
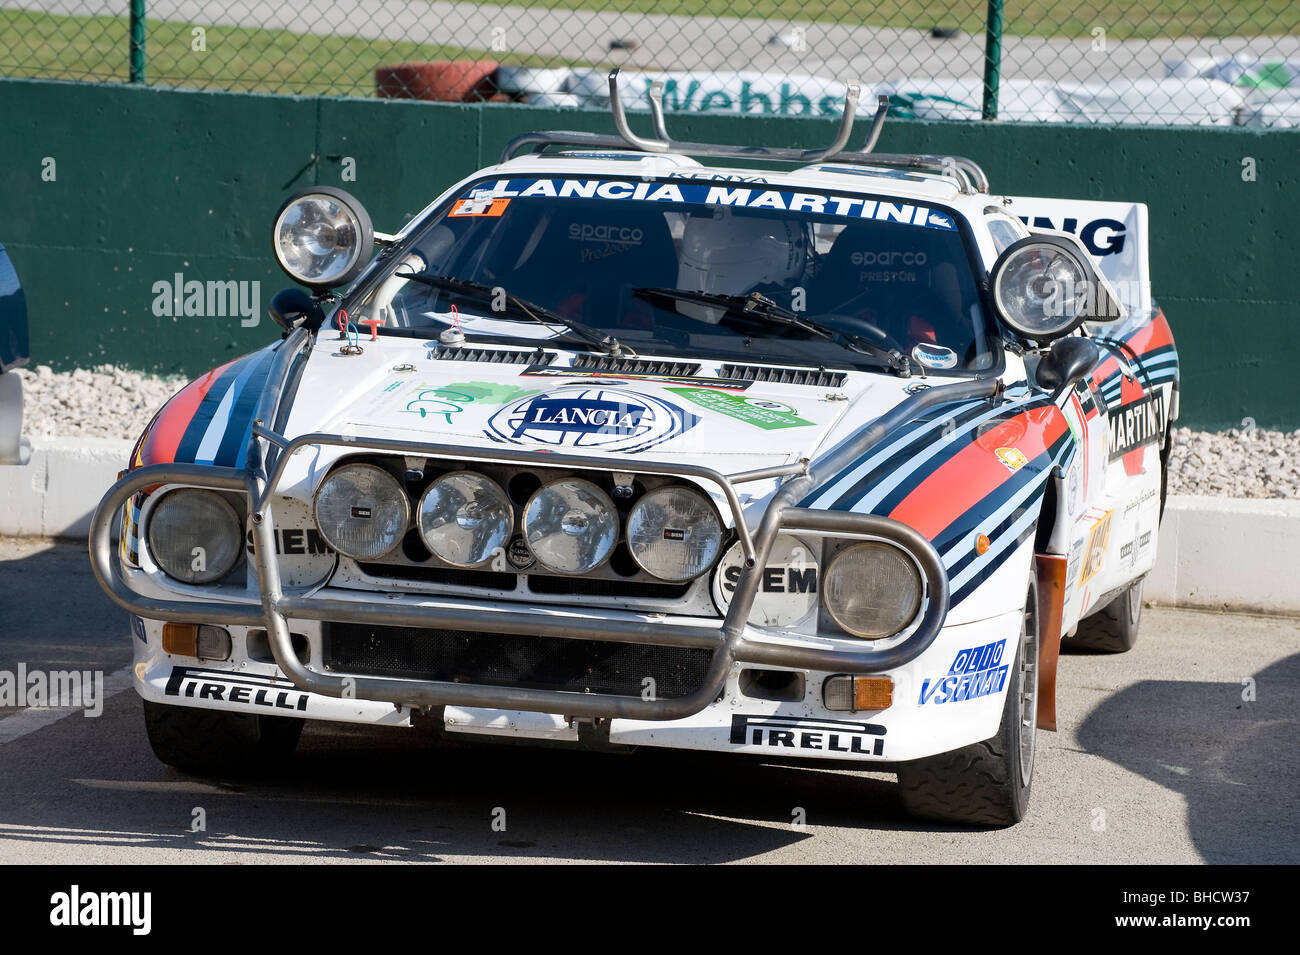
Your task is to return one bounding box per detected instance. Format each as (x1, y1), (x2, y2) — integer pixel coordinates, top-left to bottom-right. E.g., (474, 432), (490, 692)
(989, 231), (1125, 342)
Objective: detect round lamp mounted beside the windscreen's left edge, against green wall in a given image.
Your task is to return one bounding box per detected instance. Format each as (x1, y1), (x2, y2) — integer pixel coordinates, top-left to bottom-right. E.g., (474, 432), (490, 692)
(270, 186), (374, 288)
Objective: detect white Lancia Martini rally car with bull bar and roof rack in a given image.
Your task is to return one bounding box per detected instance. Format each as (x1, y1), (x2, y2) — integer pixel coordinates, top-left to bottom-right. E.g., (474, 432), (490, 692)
(91, 75), (1178, 825)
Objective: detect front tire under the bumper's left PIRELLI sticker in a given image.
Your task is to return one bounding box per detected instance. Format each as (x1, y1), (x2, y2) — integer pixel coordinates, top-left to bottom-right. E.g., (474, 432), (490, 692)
(143, 700), (303, 776)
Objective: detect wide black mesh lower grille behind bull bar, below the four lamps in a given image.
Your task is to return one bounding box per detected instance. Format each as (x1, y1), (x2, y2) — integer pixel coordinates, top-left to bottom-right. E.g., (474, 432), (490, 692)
(324, 624), (712, 699)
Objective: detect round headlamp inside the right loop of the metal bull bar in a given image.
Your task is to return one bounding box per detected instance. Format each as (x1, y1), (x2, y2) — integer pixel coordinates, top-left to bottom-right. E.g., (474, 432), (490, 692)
(822, 541), (923, 641)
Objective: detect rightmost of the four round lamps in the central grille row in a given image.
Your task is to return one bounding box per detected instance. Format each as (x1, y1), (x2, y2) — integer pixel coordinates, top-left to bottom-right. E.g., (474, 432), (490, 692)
(628, 487), (723, 582)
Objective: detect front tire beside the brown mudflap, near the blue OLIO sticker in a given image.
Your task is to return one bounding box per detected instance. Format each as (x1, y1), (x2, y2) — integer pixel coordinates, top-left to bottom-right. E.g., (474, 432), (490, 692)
(898, 579), (1040, 828)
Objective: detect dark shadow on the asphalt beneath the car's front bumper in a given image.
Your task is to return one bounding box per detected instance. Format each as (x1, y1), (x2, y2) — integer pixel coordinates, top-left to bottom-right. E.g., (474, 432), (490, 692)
(0, 691), (935, 863)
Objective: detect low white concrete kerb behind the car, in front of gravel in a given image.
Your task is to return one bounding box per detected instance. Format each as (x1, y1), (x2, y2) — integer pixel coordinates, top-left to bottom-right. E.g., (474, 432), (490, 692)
(0, 452), (1300, 613)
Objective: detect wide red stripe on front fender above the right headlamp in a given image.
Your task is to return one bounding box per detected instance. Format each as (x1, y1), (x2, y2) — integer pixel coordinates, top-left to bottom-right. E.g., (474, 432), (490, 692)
(889, 404), (1069, 541)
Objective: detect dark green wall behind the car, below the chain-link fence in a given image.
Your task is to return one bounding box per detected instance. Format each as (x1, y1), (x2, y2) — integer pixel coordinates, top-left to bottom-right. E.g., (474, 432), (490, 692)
(0, 79), (1300, 429)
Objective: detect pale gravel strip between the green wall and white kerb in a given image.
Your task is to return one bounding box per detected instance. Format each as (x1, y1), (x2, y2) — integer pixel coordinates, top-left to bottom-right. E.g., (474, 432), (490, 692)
(10, 365), (1300, 499)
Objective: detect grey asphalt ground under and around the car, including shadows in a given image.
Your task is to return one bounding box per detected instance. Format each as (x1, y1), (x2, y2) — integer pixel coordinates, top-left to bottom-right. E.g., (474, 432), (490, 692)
(0, 538), (1300, 864)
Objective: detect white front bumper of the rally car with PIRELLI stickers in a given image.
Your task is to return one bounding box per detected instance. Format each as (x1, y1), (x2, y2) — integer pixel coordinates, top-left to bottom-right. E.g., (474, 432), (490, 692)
(134, 612), (1021, 763)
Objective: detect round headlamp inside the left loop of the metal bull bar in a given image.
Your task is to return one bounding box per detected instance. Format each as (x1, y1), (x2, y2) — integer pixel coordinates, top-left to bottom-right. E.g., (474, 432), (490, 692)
(147, 487), (243, 583)
